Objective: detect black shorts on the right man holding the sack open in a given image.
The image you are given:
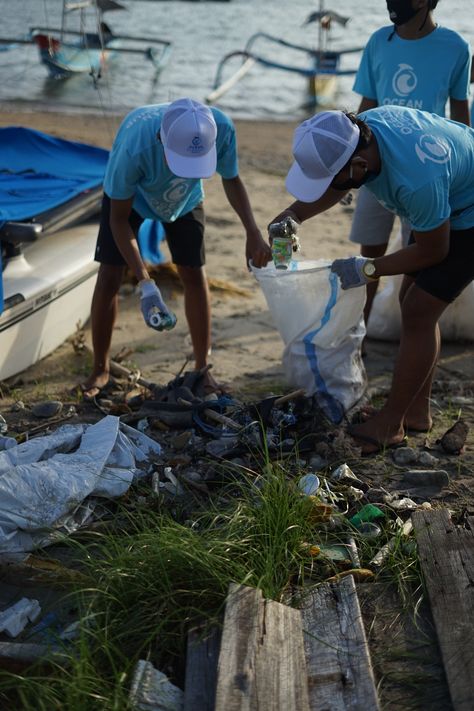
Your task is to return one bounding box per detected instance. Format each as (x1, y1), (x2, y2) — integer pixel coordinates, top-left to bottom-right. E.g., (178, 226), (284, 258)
(407, 227), (474, 304)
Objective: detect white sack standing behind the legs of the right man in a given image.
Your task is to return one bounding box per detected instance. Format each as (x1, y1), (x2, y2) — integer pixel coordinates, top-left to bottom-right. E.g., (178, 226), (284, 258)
(367, 233), (474, 341)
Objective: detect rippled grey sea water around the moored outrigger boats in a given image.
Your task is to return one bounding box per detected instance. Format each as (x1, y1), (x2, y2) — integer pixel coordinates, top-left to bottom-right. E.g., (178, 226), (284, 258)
(0, 0), (474, 119)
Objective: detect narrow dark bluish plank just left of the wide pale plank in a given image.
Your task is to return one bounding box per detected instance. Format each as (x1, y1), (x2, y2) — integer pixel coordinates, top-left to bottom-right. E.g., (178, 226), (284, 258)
(183, 628), (221, 711)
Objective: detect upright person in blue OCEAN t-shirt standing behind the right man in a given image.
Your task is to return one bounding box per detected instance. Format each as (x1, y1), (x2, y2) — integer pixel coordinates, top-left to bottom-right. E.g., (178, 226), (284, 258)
(349, 0), (471, 323)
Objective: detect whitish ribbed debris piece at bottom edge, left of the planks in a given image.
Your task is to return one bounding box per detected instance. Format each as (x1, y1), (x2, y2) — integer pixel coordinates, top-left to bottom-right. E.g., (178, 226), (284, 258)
(129, 659), (184, 711)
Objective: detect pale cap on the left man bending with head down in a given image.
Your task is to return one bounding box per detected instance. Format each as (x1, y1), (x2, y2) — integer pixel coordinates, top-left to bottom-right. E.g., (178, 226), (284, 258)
(160, 99), (217, 178)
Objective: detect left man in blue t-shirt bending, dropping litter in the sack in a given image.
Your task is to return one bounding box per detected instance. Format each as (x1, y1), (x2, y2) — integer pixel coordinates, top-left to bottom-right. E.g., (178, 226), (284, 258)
(81, 98), (271, 400)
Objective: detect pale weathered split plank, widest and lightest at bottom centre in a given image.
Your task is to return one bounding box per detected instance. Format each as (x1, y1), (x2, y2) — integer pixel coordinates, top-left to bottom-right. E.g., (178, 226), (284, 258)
(216, 585), (309, 711)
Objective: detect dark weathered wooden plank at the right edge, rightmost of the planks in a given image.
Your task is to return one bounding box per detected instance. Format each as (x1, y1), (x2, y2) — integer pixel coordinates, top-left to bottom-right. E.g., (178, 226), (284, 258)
(412, 509), (474, 711)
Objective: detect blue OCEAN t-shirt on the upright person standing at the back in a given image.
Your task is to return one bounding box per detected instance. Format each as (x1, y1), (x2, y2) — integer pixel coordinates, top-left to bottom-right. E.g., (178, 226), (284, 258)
(353, 25), (471, 116)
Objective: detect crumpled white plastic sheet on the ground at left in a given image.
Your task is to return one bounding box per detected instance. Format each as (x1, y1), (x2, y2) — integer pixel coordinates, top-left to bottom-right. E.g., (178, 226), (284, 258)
(0, 416), (161, 558)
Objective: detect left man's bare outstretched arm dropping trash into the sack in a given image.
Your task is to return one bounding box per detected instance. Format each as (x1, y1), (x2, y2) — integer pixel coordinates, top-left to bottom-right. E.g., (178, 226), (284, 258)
(222, 176), (272, 267)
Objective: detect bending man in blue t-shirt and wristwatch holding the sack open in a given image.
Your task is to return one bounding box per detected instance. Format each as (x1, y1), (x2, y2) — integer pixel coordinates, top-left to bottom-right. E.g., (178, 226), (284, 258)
(273, 106), (474, 453)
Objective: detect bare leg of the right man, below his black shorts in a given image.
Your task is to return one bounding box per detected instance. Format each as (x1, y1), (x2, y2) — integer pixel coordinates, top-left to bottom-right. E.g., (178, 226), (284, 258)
(352, 284), (448, 452)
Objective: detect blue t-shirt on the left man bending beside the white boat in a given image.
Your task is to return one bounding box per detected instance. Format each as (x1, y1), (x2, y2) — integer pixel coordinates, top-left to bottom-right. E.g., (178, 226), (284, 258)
(104, 104), (239, 222)
